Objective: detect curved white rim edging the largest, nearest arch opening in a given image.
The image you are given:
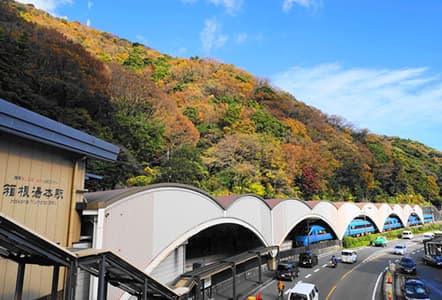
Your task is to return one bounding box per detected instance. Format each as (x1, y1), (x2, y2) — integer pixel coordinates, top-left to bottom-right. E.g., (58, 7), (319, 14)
(143, 217), (270, 274)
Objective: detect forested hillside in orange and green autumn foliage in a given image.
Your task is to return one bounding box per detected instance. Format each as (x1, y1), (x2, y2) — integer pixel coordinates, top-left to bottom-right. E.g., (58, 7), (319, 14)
(0, 1), (442, 205)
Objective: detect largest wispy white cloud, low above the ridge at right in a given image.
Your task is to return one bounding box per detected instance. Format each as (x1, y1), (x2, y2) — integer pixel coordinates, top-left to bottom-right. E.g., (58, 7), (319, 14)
(272, 63), (442, 149)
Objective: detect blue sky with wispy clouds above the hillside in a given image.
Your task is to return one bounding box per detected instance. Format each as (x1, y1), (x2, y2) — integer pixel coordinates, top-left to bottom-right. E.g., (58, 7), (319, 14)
(20, 0), (442, 151)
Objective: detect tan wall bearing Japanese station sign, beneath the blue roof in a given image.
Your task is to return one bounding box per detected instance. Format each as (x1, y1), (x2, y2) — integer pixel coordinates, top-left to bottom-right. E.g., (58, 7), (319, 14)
(0, 132), (85, 299)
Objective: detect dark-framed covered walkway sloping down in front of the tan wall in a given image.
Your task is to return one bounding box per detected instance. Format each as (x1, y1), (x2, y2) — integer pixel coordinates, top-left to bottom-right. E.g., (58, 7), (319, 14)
(0, 213), (179, 300)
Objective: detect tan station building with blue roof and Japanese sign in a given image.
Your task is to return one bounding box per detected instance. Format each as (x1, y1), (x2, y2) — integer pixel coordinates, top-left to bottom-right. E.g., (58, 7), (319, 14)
(0, 99), (119, 299)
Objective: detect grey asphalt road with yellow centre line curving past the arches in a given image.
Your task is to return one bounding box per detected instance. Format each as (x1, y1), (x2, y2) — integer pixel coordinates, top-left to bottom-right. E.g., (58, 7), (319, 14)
(262, 236), (442, 300)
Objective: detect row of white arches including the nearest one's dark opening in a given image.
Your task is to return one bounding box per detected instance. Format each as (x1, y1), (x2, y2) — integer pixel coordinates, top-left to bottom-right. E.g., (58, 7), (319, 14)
(84, 183), (432, 290)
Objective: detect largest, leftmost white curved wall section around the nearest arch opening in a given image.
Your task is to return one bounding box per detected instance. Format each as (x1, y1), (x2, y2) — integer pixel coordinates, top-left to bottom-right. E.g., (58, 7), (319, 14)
(100, 186), (224, 272)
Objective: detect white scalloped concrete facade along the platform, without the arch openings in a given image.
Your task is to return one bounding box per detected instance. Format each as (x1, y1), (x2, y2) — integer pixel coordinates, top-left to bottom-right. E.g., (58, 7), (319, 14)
(85, 183), (432, 282)
